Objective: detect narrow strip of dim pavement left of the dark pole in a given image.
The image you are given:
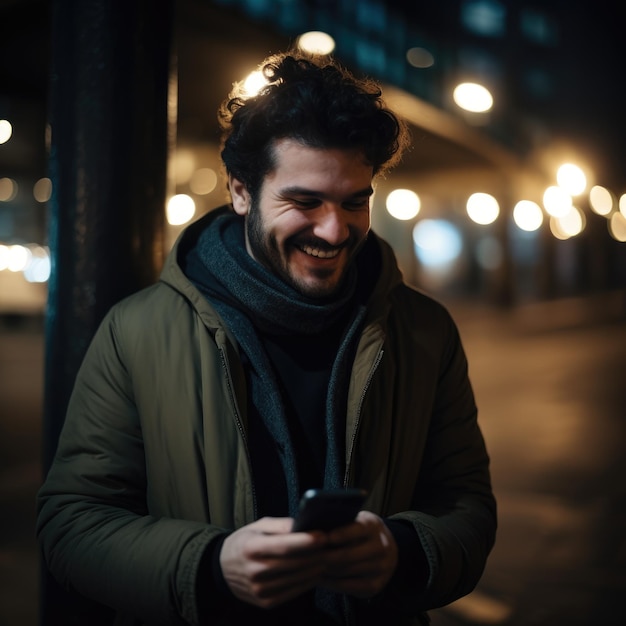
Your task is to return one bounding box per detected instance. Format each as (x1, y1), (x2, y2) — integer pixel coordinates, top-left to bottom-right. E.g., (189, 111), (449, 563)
(0, 317), (44, 626)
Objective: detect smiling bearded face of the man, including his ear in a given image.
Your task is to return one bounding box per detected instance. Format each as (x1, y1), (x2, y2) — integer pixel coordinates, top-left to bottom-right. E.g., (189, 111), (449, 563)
(230, 138), (373, 298)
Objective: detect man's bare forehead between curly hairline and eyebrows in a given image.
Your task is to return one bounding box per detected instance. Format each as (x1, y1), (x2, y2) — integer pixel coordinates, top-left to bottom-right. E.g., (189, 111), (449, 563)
(265, 138), (373, 191)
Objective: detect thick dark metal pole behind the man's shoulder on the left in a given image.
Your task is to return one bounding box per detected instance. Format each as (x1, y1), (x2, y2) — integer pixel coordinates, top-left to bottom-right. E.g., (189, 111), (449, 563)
(40, 0), (174, 626)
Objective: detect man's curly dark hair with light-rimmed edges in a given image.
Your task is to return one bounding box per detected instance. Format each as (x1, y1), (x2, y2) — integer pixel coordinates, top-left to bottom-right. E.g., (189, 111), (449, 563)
(218, 51), (409, 198)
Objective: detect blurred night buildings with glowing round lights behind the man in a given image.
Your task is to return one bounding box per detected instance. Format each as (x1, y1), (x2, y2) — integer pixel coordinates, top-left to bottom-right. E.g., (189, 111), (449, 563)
(0, 0), (626, 314)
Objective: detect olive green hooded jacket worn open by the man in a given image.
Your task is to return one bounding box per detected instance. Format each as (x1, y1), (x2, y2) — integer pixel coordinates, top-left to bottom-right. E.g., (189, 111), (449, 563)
(37, 208), (496, 625)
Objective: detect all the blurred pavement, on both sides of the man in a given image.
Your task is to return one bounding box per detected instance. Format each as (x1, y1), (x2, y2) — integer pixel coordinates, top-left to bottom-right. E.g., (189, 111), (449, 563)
(0, 293), (626, 626)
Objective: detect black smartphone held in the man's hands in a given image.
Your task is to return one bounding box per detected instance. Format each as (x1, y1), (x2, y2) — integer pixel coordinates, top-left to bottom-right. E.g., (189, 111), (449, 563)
(292, 488), (367, 532)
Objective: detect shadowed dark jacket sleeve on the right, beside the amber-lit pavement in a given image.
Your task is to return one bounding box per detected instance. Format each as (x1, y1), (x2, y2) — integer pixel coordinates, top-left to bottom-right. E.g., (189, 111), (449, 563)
(387, 304), (497, 612)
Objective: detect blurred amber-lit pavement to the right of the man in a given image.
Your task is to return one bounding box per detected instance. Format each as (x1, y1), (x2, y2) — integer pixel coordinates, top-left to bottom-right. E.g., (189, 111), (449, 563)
(431, 294), (626, 626)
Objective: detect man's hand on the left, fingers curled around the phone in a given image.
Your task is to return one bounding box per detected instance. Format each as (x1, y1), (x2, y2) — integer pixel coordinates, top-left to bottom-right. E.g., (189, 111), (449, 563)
(220, 517), (327, 609)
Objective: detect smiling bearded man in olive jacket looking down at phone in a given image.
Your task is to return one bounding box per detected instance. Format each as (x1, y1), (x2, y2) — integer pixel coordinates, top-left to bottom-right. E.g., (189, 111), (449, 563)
(38, 53), (496, 625)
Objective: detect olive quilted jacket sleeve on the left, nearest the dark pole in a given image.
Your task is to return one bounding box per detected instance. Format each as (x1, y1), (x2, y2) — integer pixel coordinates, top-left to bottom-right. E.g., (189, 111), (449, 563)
(37, 314), (221, 624)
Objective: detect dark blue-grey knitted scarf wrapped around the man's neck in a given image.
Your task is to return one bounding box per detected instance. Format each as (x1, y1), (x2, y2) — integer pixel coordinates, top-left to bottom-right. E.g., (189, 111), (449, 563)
(185, 211), (365, 517)
